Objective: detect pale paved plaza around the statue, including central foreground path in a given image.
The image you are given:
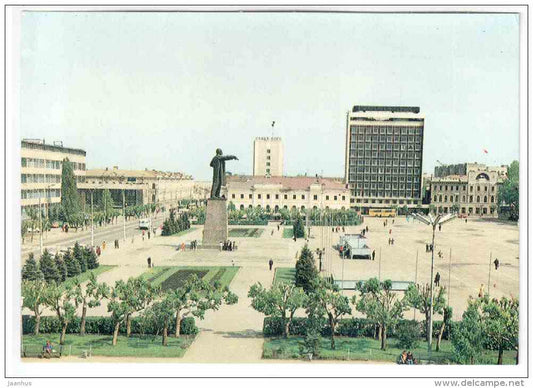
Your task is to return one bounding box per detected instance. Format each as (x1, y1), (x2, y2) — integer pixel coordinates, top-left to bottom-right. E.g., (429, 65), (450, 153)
(22, 217), (519, 362)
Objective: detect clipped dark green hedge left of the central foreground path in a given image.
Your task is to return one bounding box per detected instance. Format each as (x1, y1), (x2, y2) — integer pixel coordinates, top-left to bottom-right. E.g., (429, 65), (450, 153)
(22, 315), (198, 335)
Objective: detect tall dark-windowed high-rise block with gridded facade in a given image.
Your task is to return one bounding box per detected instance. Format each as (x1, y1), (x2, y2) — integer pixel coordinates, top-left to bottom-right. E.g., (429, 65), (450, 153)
(345, 105), (424, 213)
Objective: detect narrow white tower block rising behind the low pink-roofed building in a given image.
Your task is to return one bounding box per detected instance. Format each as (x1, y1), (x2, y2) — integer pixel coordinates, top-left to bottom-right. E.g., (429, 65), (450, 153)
(253, 137), (283, 176)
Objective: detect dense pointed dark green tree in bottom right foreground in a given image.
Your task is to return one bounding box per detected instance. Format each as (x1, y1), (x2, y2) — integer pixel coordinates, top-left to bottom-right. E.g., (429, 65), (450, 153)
(452, 299), (484, 364)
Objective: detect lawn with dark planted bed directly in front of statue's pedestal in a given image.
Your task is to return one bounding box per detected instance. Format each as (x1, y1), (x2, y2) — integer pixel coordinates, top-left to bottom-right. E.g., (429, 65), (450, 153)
(141, 266), (239, 290)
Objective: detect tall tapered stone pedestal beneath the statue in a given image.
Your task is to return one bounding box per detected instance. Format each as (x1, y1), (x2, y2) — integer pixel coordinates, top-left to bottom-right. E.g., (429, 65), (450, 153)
(202, 199), (228, 249)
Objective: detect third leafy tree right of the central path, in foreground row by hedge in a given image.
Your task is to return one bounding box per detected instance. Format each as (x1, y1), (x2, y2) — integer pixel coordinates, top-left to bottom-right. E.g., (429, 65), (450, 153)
(352, 278), (408, 350)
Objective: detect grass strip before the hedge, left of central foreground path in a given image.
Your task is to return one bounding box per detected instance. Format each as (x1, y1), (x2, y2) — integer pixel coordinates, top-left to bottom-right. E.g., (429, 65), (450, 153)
(22, 334), (194, 357)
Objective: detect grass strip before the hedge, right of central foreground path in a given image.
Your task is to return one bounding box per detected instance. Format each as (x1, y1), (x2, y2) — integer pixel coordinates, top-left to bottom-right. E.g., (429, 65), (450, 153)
(263, 337), (515, 365)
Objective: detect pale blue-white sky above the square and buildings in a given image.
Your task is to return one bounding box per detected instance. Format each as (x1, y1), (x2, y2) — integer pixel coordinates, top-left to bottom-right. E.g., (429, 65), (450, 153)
(19, 12), (519, 180)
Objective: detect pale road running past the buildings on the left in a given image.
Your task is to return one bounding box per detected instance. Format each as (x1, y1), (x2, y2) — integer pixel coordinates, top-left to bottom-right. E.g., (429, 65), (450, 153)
(22, 213), (164, 260)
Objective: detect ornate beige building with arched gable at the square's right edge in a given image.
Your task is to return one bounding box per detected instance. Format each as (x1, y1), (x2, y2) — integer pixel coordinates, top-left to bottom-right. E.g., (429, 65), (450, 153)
(431, 163), (507, 217)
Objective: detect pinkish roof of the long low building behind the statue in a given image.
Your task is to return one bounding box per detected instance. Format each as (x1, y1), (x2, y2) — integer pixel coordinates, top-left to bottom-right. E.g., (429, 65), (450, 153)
(227, 175), (348, 190)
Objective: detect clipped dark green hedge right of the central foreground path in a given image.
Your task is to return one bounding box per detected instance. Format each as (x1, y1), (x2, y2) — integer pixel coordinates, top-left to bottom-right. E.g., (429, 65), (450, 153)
(263, 317), (453, 339)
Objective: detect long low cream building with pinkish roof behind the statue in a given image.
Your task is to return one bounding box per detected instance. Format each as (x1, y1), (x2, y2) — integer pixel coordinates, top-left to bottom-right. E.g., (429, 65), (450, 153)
(226, 175), (350, 212)
